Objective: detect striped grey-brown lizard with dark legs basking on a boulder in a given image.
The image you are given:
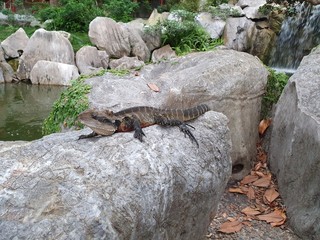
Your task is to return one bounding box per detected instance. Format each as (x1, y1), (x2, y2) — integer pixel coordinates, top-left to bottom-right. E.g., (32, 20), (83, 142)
(79, 104), (210, 147)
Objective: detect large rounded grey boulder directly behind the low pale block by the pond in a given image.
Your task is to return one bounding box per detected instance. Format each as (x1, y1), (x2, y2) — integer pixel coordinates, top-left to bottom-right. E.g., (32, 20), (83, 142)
(17, 29), (75, 80)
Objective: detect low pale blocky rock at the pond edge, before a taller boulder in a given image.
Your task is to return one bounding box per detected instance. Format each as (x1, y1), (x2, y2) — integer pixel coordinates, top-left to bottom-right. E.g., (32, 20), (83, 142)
(30, 60), (79, 86)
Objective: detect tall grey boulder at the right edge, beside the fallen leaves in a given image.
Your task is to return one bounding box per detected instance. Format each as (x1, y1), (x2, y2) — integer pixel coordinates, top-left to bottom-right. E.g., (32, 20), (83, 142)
(269, 47), (320, 239)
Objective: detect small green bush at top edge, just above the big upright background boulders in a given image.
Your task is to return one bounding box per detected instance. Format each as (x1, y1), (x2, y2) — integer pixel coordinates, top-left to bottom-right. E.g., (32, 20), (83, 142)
(104, 0), (139, 22)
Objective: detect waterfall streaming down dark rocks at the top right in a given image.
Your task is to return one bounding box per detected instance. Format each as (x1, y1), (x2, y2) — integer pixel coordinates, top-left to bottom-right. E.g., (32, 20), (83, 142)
(268, 2), (320, 72)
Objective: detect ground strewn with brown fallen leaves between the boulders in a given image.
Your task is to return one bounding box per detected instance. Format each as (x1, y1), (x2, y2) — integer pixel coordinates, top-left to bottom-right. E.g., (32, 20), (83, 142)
(206, 136), (301, 240)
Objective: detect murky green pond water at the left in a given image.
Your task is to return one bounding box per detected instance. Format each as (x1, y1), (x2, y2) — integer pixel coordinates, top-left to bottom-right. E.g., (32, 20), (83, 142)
(0, 83), (65, 141)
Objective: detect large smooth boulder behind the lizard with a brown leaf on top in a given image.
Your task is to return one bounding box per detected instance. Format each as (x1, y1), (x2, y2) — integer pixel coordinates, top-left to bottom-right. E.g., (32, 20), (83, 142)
(87, 50), (268, 179)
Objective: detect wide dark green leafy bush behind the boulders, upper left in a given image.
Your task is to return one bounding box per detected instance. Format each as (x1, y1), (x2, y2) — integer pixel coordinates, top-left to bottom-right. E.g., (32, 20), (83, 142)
(37, 0), (104, 32)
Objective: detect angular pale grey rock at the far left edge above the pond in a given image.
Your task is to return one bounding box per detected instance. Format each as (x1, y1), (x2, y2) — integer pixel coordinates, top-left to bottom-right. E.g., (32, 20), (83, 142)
(1, 28), (29, 58)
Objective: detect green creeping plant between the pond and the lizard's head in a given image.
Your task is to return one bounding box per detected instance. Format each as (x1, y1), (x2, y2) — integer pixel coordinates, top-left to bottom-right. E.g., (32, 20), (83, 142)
(42, 75), (91, 134)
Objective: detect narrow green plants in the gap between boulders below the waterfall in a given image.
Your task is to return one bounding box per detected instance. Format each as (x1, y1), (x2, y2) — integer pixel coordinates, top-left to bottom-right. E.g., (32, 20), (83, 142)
(261, 68), (289, 119)
